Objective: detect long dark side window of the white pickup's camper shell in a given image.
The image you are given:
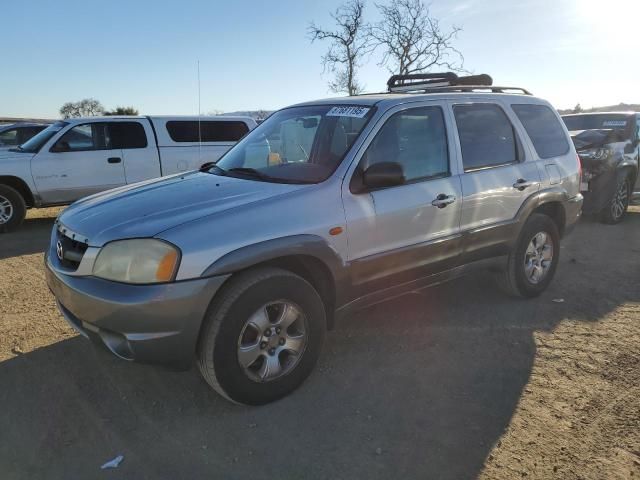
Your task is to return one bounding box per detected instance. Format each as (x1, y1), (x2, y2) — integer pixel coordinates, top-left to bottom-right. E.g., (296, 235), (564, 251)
(167, 120), (249, 143)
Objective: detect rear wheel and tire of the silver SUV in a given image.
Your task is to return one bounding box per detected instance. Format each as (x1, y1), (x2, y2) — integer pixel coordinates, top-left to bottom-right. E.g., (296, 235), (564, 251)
(499, 213), (560, 298)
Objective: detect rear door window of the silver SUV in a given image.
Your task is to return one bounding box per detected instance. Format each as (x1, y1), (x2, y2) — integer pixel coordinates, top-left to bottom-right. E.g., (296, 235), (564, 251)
(453, 103), (522, 171)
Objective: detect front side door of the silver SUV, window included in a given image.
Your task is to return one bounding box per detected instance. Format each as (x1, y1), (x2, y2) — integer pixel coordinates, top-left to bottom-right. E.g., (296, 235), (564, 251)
(343, 102), (462, 290)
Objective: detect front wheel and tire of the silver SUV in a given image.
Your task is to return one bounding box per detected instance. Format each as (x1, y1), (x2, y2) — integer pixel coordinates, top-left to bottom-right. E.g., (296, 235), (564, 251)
(197, 268), (326, 405)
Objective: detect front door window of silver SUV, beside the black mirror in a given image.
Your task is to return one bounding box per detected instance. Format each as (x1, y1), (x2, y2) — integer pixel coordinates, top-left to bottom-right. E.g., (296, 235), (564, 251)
(360, 107), (449, 182)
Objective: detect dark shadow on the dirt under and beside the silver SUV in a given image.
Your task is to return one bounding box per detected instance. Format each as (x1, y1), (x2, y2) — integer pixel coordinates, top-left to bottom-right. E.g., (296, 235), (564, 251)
(0, 212), (640, 479)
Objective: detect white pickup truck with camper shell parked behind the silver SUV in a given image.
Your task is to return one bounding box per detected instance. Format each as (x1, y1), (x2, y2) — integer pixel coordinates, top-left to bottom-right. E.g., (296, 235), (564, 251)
(0, 116), (256, 232)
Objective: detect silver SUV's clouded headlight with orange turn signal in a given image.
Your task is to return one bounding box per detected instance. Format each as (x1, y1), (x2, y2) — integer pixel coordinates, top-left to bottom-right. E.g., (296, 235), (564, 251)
(93, 238), (180, 283)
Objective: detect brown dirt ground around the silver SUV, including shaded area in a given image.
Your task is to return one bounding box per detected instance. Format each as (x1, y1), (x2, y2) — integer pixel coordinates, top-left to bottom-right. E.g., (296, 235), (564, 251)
(0, 207), (640, 479)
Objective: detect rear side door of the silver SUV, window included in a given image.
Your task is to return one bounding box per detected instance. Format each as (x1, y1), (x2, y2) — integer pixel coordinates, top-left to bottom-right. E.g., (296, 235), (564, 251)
(450, 102), (540, 261)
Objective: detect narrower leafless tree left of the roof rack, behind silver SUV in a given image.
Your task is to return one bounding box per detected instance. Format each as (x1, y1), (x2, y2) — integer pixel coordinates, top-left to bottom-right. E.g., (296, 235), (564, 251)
(308, 0), (371, 95)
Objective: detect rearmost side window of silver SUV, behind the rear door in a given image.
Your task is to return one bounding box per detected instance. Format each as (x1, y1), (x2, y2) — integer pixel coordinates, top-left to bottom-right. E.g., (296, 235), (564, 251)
(511, 104), (569, 158)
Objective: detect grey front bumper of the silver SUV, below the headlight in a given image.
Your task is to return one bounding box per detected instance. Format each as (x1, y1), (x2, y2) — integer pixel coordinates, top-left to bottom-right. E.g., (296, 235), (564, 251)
(45, 259), (228, 368)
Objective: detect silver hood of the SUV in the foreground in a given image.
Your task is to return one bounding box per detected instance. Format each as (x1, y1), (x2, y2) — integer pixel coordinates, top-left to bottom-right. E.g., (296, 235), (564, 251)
(59, 172), (308, 247)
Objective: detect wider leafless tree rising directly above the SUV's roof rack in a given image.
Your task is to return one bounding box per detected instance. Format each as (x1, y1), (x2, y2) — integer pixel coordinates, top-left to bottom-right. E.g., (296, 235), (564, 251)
(369, 0), (464, 75)
